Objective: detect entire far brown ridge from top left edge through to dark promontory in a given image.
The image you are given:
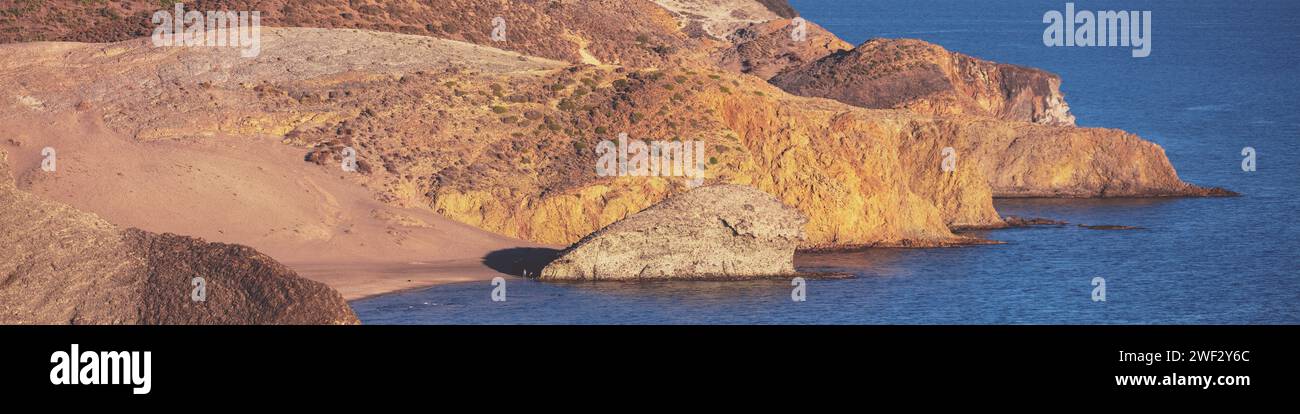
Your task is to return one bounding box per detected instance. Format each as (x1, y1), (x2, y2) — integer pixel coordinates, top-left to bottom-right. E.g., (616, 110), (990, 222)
(0, 0), (1074, 125)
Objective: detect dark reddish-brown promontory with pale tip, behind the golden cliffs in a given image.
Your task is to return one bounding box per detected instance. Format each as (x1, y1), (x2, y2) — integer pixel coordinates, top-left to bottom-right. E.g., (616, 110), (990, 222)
(771, 39), (1074, 125)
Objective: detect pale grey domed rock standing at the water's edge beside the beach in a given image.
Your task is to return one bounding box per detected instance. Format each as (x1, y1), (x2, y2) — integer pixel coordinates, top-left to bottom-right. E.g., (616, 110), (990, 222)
(541, 185), (807, 280)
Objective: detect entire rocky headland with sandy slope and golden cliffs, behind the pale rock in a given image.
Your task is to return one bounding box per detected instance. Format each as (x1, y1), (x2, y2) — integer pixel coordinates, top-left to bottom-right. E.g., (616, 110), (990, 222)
(0, 0), (1231, 291)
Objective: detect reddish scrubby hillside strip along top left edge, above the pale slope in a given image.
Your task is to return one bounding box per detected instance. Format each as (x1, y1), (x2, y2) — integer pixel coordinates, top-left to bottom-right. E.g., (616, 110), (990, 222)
(0, 0), (702, 66)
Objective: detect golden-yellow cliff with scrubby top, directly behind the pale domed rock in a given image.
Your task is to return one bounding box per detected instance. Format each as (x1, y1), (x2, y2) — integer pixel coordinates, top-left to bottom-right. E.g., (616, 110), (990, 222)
(399, 63), (1001, 247)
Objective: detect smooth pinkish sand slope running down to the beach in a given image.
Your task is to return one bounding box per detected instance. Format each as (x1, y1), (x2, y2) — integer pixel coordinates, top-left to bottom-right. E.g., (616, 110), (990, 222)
(0, 109), (548, 299)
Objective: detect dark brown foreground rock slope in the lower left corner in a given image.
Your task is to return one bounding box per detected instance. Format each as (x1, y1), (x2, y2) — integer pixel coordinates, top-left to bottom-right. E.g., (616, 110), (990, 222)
(0, 151), (359, 324)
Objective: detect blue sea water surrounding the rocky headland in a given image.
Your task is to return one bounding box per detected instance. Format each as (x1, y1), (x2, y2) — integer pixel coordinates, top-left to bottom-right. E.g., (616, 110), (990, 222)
(352, 0), (1300, 324)
